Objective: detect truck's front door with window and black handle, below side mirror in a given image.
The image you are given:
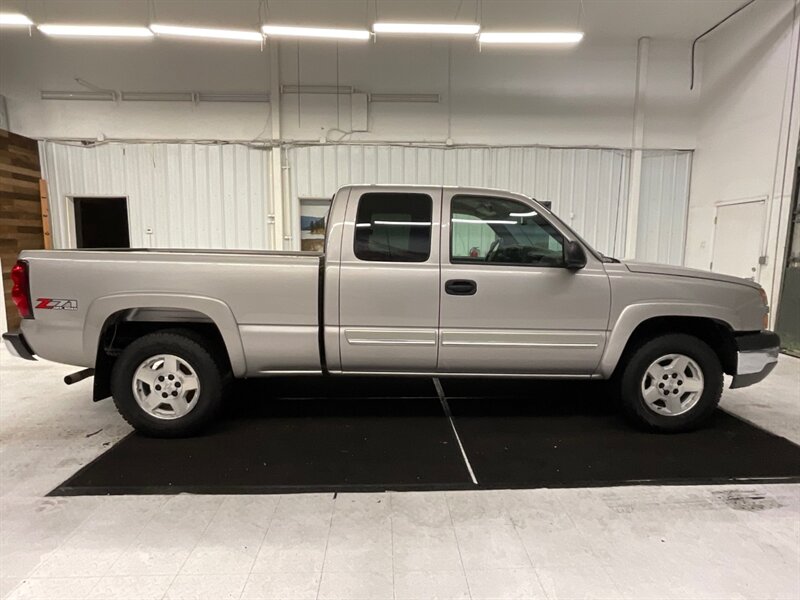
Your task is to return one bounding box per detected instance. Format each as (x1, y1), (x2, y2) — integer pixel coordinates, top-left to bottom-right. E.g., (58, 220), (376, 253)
(438, 190), (611, 375)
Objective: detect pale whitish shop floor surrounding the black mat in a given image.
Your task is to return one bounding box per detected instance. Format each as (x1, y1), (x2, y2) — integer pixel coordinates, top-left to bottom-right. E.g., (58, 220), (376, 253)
(0, 348), (800, 600)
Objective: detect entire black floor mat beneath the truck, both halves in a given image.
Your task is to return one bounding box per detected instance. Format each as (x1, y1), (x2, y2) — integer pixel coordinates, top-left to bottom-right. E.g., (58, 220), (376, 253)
(51, 378), (800, 495)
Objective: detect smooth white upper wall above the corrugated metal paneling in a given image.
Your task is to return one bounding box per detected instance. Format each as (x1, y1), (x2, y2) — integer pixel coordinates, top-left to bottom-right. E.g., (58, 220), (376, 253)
(0, 28), (697, 148)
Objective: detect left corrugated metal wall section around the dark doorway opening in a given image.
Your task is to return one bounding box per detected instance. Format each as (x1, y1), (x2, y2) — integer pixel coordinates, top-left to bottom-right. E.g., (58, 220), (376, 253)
(39, 142), (272, 250)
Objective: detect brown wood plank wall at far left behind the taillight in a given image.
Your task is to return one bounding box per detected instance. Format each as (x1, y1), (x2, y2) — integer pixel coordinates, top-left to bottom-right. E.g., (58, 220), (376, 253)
(0, 129), (44, 329)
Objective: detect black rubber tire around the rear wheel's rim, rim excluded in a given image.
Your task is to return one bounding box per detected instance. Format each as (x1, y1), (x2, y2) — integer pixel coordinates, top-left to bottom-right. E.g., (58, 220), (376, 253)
(111, 329), (230, 438)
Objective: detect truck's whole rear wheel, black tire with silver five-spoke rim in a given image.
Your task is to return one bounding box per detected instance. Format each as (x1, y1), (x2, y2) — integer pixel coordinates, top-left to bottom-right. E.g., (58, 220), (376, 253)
(111, 330), (227, 437)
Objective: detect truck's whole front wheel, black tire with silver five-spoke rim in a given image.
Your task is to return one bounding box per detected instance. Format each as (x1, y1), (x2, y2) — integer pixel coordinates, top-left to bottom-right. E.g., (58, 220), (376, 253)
(620, 334), (723, 432)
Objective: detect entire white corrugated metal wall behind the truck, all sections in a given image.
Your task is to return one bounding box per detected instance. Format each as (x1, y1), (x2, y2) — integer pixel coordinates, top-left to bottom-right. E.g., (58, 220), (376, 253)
(39, 142), (692, 264)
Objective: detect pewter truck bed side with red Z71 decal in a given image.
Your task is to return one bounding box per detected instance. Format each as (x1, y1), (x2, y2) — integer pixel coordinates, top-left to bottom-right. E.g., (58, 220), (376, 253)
(20, 249), (323, 376)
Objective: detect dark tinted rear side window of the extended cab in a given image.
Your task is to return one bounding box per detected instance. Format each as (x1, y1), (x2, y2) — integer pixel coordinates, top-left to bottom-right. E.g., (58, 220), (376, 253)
(354, 193), (433, 262)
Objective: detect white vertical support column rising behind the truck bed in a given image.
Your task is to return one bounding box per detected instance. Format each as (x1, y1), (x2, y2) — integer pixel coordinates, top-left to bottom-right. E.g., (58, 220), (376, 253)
(269, 38), (286, 250)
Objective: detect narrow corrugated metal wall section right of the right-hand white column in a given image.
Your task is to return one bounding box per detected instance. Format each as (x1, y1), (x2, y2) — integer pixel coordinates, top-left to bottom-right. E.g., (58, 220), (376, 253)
(636, 150), (692, 265)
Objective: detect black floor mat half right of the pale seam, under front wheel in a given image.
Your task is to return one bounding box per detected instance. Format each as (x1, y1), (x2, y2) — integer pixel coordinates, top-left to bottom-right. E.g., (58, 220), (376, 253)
(443, 380), (800, 488)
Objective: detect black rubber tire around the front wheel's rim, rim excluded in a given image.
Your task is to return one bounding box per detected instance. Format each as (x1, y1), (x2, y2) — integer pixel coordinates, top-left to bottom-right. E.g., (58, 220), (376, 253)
(619, 333), (723, 432)
